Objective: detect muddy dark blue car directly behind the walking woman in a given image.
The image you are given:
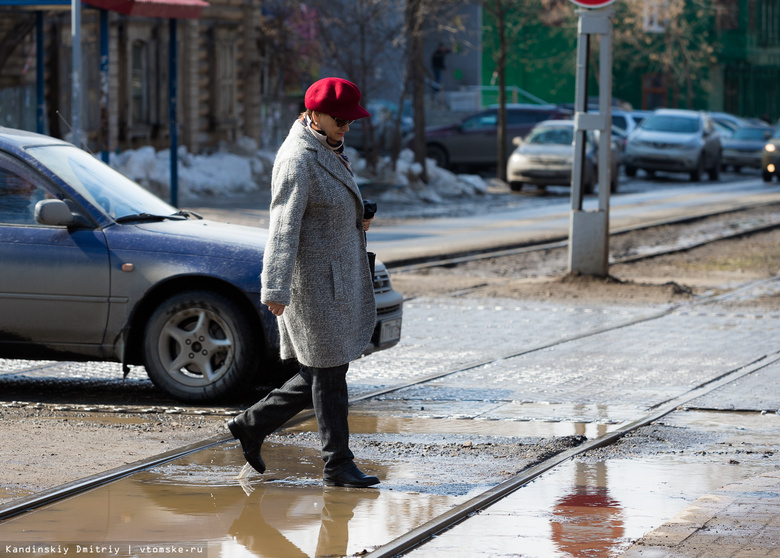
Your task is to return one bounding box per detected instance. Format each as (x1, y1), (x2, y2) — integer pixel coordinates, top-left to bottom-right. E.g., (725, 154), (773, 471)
(0, 127), (402, 401)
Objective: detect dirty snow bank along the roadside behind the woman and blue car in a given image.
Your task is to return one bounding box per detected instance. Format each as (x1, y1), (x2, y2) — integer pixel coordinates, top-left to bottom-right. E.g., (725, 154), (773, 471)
(110, 138), (487, 203)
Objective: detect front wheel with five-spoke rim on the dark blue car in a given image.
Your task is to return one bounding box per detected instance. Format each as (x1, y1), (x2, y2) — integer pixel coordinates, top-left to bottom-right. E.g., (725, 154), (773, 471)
(144, 291), (258, 401)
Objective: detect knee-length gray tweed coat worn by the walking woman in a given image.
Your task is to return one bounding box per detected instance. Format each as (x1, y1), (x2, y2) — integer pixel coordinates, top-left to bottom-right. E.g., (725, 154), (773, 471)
(260, 121), (376, 368)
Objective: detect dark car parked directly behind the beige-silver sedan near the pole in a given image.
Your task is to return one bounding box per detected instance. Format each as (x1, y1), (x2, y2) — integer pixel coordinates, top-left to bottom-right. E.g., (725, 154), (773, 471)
(409, 104), (571, 168)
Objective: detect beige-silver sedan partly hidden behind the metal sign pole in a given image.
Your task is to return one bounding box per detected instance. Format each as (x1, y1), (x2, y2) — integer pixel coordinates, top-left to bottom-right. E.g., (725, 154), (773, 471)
(507, 120), (619, 194)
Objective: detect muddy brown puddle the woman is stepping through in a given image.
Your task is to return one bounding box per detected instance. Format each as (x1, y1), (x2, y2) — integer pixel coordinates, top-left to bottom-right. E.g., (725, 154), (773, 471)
(0, 443), (458, 558)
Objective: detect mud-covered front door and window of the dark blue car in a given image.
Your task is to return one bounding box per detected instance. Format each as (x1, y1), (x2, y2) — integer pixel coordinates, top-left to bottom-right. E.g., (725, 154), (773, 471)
(0, 154), (110, 358)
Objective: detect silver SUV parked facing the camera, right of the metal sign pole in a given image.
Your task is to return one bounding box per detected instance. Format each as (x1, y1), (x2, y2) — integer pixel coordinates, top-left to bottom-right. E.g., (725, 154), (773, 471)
(623, 109), (721, 182)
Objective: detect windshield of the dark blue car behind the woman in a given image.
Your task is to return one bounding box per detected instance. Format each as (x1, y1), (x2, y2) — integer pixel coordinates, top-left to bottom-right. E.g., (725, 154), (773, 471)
(27, 145), (177, 219)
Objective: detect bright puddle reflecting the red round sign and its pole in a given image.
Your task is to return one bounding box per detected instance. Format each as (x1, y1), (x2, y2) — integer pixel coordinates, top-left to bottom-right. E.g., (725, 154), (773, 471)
(406, 455), (750, 558)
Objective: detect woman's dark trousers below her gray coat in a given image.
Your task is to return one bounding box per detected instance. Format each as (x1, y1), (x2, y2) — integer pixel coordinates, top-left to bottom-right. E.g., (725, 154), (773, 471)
(235, 364), (355, 476)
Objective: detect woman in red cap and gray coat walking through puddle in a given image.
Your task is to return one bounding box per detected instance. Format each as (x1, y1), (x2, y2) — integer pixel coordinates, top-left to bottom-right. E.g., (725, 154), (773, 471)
(228, 78), (379, 487)
